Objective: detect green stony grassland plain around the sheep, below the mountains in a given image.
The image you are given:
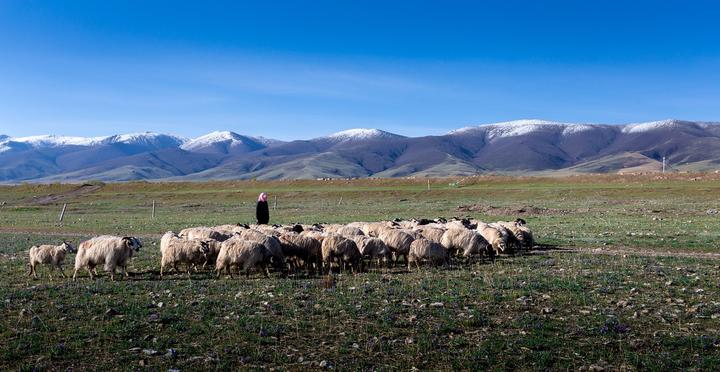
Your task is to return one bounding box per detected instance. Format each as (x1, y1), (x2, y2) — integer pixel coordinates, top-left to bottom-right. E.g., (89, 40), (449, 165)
(0, 174), (720, 370)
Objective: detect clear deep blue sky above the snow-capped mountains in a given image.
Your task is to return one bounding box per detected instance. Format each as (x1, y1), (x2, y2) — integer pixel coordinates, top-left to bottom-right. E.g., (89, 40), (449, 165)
(0, 0), (720, 139)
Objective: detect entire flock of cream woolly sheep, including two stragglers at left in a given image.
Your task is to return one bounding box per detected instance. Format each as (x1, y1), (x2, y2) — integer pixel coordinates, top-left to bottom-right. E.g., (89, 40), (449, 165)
(29, 218), (534, 280)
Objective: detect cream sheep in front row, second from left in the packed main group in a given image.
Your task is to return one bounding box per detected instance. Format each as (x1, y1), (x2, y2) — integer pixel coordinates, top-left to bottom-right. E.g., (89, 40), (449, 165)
(215, 235), (282, 278)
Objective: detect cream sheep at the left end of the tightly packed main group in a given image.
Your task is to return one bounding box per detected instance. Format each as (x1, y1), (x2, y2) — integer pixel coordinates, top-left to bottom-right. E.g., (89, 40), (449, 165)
(160, 231), (210, 279)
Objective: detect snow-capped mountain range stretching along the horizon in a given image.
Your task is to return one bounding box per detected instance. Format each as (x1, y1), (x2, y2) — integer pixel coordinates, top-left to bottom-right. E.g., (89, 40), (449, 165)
(0, 120), (720, 183)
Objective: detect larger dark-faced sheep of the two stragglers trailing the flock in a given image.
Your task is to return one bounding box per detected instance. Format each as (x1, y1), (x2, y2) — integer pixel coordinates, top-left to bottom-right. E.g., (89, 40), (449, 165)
(73, 235), (142, 281)
